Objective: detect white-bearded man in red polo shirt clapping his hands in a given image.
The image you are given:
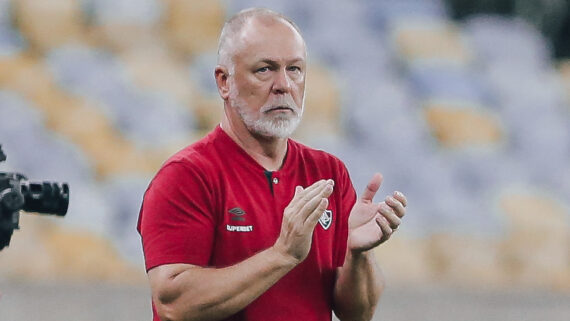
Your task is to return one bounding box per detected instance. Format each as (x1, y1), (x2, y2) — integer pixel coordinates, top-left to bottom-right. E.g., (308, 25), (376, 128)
(138, 9), (406, 321)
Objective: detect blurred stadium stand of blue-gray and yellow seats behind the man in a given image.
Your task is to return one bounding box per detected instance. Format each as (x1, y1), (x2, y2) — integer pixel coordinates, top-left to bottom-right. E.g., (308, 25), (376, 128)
(0, 0), (570, 290)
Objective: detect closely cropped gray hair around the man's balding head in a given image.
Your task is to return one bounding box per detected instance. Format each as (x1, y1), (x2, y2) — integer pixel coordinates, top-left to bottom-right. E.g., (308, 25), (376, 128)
(218, 8), (302, 74)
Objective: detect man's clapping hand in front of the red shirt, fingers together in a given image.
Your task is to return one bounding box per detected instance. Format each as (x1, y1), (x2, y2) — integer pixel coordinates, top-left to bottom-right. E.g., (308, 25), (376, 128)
(273, 179), (334, 264)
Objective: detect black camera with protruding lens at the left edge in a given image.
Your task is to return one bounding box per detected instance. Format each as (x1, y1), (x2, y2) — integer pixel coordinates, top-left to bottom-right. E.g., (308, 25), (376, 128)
(0, 145), (69, 250)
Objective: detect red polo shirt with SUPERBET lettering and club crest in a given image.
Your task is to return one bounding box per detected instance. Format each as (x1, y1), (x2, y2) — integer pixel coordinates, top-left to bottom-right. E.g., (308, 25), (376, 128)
(137, 126), (356, 321)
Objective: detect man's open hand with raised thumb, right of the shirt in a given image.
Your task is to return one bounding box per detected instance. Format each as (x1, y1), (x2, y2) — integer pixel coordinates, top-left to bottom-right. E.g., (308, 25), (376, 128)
(348, 173), (407, 252)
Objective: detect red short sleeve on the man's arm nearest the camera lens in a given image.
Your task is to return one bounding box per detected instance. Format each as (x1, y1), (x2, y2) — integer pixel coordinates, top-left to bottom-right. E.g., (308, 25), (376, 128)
(137, 162), (215, 271)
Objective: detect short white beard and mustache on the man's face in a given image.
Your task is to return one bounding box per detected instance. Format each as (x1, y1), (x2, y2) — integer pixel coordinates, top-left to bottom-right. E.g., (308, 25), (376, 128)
(229, 87), (305, 138)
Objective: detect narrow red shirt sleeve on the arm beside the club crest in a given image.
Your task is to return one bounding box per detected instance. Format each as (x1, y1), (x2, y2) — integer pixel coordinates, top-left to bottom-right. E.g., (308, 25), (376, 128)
(335, 160), (356, 267)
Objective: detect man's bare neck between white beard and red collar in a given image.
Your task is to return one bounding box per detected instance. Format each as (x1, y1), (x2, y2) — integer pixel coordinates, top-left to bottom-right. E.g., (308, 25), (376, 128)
(220, 117), (287, 171)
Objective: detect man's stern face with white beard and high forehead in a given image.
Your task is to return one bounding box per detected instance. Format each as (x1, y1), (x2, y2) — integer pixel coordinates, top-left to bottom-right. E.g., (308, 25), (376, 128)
(228, 18), (306, 138)
